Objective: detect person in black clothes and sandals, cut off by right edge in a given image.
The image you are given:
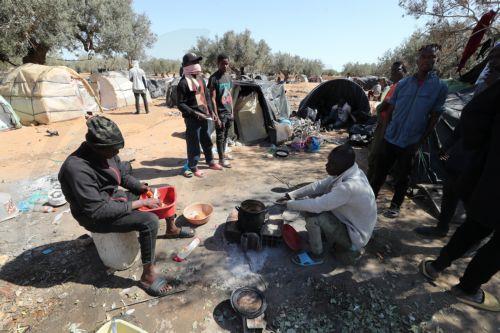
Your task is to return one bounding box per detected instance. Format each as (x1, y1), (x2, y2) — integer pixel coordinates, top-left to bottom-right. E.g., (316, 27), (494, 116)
(420, 81), (500, 312)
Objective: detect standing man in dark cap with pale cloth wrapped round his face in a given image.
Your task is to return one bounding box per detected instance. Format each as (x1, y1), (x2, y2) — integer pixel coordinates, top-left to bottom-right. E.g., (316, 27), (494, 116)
(177, 53), (222, 178)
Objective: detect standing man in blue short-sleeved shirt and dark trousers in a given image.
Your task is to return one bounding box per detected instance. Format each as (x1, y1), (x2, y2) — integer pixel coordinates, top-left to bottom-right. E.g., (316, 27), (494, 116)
(370, 44), (448, 218)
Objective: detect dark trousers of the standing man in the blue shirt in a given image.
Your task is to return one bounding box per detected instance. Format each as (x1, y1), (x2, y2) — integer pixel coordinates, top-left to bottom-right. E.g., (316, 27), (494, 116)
(370, 139), (415, 207)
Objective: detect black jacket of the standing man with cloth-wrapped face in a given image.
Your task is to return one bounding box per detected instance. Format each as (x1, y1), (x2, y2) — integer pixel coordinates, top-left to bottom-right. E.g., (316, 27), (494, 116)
(177, 76), (211, 119)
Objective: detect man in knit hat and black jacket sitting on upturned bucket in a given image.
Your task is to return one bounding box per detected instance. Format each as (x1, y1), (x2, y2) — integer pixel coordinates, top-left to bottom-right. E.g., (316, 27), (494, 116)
(59, 116), (194, 296)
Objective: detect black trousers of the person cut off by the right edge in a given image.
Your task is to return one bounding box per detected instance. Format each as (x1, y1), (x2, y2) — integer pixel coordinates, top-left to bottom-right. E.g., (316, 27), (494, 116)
(432, 218), (500, 294)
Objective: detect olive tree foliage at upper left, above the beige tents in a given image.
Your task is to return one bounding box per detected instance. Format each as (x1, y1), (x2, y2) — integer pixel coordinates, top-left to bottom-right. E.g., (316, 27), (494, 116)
(0, 0), (156, 64)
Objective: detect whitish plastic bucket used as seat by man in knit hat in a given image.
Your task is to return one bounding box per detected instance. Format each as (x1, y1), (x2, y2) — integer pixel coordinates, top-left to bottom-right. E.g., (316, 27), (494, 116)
(92, 231), (140, 271)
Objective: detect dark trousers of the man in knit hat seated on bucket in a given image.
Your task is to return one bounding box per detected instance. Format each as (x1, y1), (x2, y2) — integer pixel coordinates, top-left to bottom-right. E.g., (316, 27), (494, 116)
(85, 210), (158, 265)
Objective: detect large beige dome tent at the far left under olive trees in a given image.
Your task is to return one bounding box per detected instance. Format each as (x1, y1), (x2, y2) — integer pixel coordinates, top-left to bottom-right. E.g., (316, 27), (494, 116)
(0, 64), (100, 124)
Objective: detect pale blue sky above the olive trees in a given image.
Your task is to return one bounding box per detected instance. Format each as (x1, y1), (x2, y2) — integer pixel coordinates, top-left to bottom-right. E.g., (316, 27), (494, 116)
(133, 0), (423, 70)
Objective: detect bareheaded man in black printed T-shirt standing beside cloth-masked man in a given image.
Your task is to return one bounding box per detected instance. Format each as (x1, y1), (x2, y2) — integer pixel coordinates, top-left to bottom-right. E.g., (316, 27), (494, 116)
(208, 54), (234, 168)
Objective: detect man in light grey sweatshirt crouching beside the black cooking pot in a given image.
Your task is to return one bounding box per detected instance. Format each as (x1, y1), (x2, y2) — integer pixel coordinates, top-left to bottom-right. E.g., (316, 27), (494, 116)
(278, 145), (377, 266)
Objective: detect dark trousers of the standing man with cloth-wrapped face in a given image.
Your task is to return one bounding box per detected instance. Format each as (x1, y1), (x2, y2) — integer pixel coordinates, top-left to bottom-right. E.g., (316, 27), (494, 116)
(184, 118), (214, 171)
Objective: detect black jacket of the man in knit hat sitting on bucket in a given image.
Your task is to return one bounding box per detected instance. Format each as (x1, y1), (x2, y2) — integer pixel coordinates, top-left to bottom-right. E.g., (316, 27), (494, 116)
(59, 142), (145, 227)
